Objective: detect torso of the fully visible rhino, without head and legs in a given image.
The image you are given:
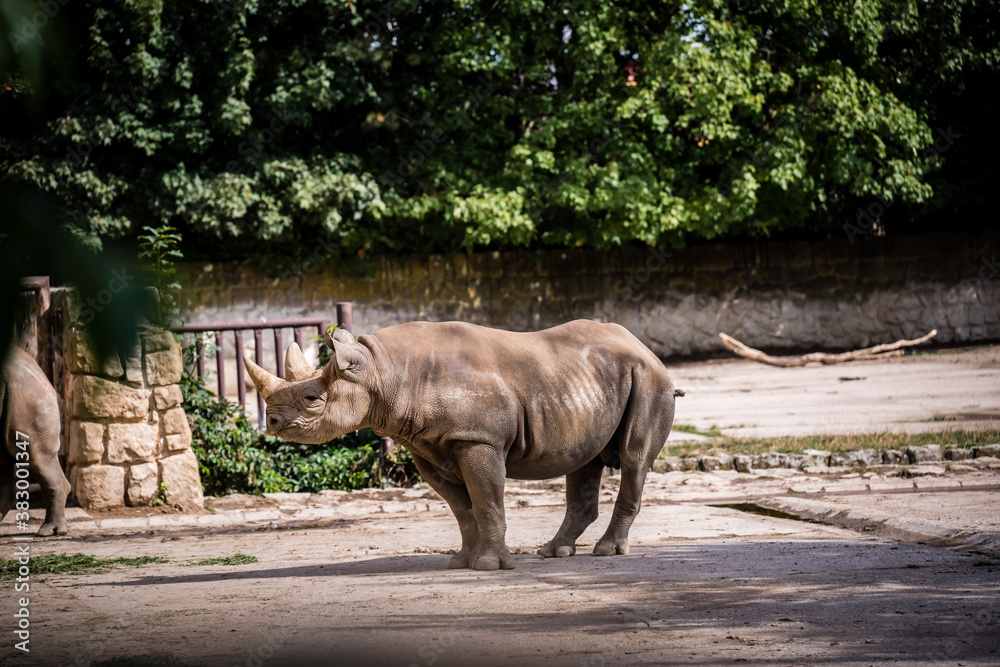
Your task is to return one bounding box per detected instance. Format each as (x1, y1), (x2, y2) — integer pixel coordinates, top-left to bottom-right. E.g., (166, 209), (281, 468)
(362, 320), (673, 478)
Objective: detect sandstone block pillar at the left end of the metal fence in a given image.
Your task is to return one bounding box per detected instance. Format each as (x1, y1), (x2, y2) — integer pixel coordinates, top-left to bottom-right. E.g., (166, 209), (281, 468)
(53, 291), (203, 509)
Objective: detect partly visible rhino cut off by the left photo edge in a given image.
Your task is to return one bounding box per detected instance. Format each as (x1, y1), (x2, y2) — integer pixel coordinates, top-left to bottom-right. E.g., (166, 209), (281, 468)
(0, 348), (70, 535)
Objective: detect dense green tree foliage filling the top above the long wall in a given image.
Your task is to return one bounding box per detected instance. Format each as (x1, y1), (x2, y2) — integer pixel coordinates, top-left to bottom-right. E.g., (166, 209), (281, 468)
(0, 0), (1000, 257)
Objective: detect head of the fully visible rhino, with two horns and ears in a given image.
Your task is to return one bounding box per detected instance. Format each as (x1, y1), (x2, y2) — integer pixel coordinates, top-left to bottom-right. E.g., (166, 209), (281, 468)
(246, 329), (373, 445)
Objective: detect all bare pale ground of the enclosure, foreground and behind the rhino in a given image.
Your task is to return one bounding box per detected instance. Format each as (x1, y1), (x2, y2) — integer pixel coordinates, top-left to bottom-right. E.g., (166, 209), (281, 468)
(0, 348), (1000, 667)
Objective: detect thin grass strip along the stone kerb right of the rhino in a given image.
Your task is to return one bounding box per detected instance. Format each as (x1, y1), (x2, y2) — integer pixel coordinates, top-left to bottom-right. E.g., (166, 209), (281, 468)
(660, 424), (1000, 458)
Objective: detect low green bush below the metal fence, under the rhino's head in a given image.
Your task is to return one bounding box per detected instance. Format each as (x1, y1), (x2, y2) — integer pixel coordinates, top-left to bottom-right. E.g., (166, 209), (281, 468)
(181, 373), (418, 496)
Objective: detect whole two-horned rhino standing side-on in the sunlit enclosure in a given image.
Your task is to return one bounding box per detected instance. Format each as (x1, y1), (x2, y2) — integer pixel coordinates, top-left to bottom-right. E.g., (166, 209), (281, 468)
(247, 320), (680, 570)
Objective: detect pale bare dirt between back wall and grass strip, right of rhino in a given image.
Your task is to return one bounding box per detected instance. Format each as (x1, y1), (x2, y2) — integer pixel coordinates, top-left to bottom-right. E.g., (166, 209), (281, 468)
(670, 345), (1000, 440)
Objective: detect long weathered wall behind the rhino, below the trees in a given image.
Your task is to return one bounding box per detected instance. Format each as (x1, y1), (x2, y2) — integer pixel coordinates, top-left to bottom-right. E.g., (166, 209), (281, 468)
(181, 231), (1000, 378)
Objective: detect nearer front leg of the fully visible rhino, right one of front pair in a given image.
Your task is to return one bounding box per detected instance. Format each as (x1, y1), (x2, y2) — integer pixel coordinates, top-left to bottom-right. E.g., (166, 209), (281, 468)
(455, 443), (514, 570)
